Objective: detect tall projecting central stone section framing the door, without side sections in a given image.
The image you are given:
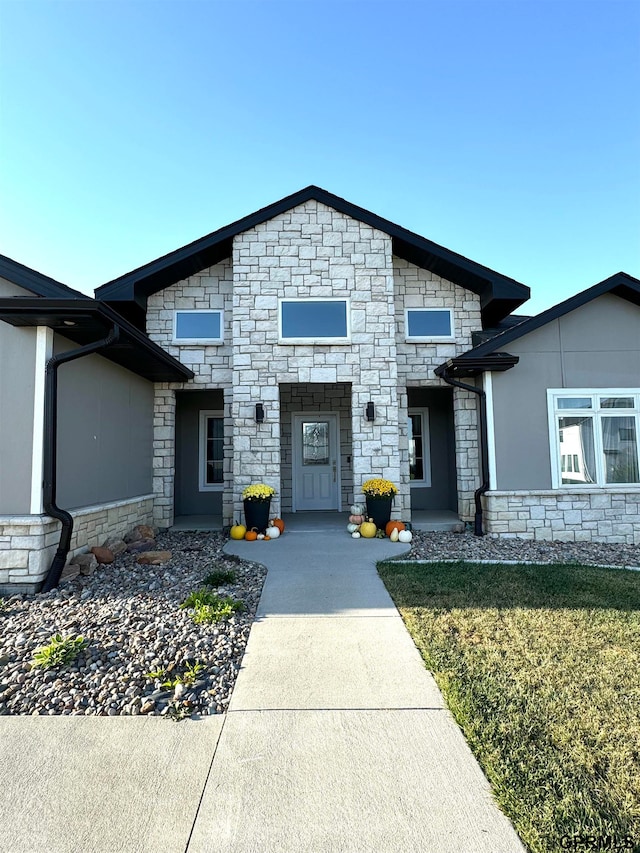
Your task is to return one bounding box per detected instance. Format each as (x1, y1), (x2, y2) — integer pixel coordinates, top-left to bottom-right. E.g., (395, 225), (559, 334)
(232, 201), (409, 512)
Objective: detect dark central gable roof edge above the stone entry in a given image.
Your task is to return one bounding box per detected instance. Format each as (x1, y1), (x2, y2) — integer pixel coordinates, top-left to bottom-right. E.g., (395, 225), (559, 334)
(96, 186), (530, 324)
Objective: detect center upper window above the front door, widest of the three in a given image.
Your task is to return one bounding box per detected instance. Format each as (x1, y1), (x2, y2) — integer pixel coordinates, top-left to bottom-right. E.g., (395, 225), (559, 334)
(278, 297), (351, 344)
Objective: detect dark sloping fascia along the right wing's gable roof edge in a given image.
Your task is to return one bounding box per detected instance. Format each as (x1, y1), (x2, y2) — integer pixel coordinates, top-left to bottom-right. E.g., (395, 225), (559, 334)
(460, 272), (640, 359)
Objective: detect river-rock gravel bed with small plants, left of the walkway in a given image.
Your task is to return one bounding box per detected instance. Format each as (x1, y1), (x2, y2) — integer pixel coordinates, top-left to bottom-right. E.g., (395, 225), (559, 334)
(0, 532), (266, 718)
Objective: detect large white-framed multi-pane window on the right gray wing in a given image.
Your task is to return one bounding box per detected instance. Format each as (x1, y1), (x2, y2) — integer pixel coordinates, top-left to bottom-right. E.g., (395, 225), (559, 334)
(547, 388), (640, 489)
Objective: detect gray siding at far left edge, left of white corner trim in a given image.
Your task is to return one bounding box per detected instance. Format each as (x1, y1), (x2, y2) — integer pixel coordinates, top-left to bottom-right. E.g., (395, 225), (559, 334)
(0, 278), (36, 515)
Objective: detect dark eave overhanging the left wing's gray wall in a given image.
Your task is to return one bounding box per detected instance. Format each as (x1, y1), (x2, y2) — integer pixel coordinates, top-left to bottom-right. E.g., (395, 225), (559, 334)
(0, 296), (194, 382)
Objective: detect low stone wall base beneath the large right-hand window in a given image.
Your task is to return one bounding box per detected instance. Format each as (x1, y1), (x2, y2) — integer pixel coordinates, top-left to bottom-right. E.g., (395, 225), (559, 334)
(484, 489), (640, 545)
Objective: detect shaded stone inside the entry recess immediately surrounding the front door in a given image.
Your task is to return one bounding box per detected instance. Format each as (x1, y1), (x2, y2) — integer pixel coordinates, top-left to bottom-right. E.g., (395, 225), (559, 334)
(280, 383), (352, 512)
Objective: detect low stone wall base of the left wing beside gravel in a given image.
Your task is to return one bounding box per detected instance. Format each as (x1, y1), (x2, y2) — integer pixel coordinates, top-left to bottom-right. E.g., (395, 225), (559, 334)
(0, 495), (153, 594)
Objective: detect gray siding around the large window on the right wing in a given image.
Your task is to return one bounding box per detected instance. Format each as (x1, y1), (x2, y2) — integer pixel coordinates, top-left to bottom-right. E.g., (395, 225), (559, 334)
(493, 294), (640, 491)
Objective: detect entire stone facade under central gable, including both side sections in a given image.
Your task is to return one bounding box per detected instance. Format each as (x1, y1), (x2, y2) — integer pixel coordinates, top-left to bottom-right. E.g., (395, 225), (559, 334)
(147, 200), (481, 526)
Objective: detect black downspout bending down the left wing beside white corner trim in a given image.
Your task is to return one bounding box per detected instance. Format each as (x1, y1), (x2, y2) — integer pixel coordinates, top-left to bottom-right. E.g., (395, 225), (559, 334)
(41, 323), (120, 592)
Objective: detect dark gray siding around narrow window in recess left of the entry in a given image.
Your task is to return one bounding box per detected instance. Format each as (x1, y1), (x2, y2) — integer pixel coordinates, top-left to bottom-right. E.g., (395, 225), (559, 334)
(175, 390), (224, 516)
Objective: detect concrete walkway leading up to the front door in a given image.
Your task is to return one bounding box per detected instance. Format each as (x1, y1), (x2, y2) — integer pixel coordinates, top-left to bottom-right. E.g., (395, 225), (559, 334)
(0, 532), (523, 853)
